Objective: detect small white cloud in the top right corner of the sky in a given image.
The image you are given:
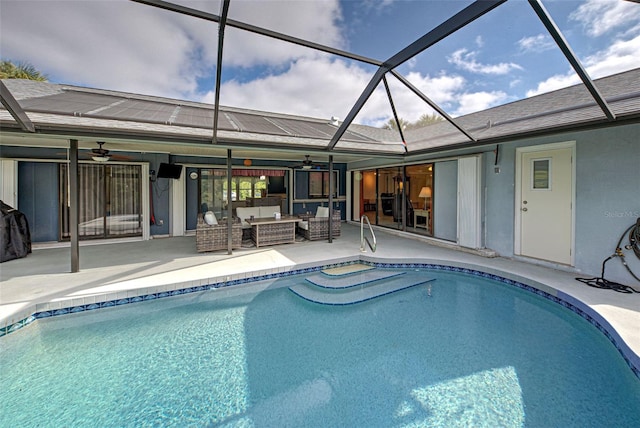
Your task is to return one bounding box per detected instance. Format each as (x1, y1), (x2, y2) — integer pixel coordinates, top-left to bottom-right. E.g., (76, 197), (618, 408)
(569, 0), (640, 37)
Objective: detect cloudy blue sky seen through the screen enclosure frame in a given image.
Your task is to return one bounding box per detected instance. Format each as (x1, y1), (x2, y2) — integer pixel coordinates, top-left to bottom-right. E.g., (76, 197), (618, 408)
(0, 0), (640, 126)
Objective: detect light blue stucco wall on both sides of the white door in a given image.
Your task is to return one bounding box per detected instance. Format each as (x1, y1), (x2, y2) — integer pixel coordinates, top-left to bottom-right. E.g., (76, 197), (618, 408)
(484, 124), (640, 285)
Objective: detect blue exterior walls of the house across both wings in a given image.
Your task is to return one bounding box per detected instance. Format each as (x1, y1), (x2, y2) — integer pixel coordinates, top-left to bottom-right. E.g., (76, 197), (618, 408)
(2, 124), (640, 286)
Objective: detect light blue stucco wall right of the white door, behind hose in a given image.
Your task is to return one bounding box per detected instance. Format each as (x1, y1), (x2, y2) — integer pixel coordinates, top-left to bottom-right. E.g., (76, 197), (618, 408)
(576, 125), (640, 288)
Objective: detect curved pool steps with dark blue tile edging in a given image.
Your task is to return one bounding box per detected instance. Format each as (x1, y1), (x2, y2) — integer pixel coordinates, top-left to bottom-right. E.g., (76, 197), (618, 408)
(289, 271), (434, 306)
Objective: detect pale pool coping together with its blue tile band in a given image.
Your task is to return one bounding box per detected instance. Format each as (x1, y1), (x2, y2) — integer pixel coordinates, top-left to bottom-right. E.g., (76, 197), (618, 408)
(0, 254), (640, 379)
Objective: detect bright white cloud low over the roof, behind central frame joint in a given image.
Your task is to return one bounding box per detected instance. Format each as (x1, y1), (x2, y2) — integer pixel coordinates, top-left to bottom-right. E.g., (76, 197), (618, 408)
(212, 58), (472, 126)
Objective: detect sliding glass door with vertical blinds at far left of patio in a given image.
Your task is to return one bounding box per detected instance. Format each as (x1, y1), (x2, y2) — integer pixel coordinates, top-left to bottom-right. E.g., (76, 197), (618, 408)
(59, 164), (143, 240)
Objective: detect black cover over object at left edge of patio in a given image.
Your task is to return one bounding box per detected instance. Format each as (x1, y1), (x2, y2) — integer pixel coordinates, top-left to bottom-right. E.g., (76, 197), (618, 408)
(0, 201), (31, 262)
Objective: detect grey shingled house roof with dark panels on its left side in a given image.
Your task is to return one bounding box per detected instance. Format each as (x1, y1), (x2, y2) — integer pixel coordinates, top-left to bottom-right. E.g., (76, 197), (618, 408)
(0, 69), (640, 158)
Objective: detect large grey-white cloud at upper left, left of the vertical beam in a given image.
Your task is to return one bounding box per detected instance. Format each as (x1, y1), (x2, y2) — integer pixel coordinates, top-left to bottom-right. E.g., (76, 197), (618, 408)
(0, 1), (215, 97)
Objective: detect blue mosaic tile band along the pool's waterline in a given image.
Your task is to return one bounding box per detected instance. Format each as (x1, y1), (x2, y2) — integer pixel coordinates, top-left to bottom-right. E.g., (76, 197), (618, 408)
(0, 258), (640, 379)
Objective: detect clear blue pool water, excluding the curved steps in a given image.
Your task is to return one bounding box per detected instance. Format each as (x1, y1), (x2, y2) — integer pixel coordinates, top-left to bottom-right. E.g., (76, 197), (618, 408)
(0, 272), (640, 427)
